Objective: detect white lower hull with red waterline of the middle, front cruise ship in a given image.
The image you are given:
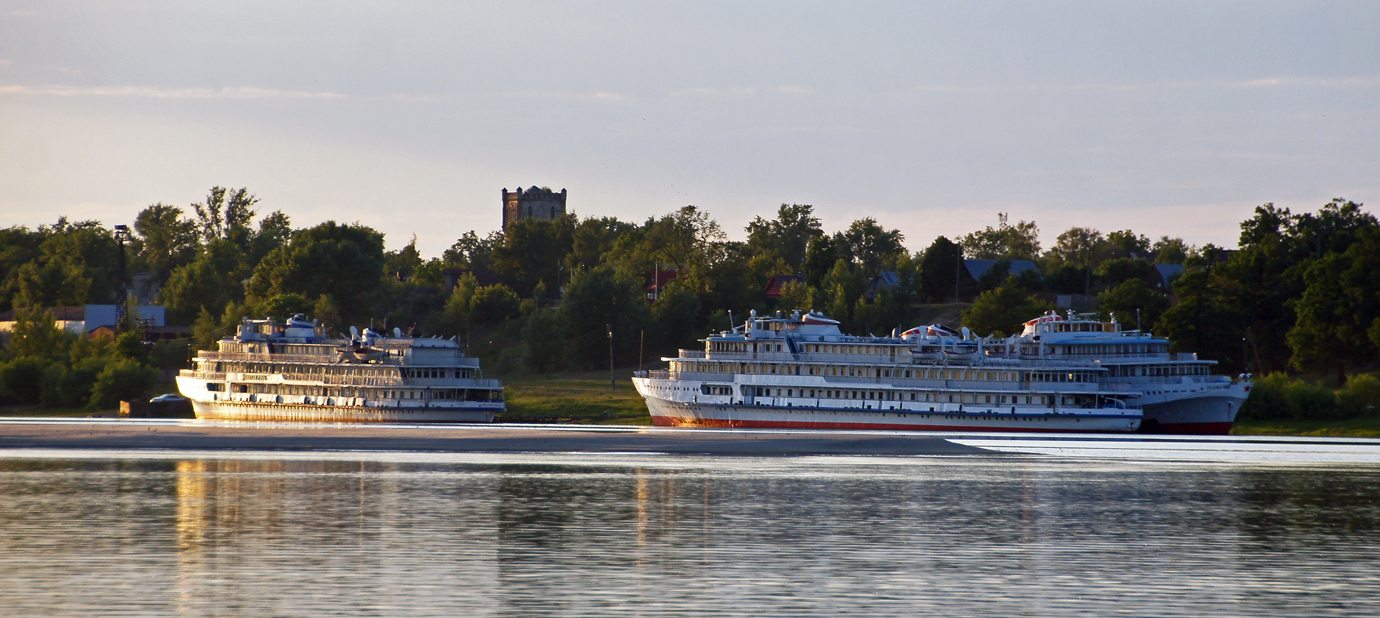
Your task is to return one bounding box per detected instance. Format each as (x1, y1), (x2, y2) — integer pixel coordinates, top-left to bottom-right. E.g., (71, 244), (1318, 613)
(633, 378), (1141, 433)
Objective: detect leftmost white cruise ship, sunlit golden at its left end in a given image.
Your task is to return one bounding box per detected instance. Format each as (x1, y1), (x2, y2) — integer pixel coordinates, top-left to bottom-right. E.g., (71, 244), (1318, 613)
(177, 316), (504, 422)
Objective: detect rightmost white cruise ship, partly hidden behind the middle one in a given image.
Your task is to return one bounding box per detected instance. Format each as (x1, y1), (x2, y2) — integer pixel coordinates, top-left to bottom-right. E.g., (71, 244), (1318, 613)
(989, 312), (1252, 435)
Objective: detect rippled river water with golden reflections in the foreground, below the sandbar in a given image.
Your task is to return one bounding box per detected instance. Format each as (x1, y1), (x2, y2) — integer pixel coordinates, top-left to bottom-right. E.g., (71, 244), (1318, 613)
(0, 455), (1380, 617)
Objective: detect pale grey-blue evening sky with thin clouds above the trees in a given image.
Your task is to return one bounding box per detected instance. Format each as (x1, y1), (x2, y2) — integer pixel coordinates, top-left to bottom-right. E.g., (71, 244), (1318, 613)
(0, 0), (1380, 257)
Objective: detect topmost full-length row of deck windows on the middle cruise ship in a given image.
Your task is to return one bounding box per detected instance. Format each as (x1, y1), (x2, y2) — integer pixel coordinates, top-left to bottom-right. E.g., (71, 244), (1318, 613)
(672, 360), (1098, 382)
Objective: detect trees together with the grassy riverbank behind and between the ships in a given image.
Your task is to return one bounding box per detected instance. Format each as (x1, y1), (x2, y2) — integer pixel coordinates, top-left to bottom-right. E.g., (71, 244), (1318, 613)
(0, 186), (1380, 435)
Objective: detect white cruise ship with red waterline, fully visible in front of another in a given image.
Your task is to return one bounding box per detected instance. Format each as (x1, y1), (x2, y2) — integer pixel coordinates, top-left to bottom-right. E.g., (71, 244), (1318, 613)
(633, 313), (1141, 432)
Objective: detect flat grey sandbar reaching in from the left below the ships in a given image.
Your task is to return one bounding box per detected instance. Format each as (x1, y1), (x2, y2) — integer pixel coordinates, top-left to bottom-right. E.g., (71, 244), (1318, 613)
(0, 419), (995, 455)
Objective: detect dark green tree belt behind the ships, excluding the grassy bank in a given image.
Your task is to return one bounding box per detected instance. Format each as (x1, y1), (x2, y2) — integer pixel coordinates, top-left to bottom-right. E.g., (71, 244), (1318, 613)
(0, 188), (1380, 413)
